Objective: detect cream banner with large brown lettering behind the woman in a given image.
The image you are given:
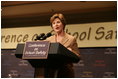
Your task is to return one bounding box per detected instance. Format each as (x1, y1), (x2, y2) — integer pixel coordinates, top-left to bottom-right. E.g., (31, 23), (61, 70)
(1, 22), (117, 49)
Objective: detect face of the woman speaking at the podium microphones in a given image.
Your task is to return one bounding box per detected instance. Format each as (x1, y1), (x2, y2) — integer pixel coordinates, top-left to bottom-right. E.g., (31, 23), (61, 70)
(52, 18), (64, 33)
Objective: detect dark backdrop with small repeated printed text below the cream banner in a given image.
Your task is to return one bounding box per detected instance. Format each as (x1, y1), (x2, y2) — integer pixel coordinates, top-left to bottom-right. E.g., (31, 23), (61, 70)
(1, 47), (117, 78)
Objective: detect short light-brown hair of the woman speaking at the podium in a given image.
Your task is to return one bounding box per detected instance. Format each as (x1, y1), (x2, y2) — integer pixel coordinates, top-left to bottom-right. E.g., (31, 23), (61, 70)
(50, 13), (66, 29)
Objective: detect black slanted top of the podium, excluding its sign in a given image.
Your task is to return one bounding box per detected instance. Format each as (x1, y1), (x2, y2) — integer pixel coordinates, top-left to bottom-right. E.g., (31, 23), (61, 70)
(15, 43), (80, 77)
